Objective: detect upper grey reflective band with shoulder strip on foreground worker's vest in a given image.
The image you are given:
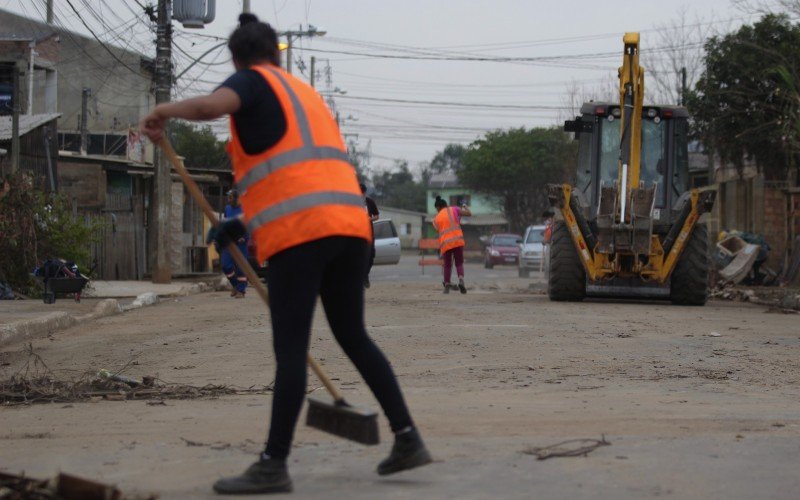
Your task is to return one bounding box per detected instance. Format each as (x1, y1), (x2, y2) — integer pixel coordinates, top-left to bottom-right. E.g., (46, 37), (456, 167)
(236, 68), (350, 193)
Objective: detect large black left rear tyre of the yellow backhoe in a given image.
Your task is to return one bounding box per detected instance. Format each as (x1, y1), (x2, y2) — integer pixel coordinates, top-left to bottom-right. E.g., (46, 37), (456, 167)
(547, 221), (586, 302)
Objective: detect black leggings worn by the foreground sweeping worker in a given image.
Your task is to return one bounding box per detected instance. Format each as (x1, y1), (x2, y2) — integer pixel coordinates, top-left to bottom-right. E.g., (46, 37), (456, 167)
(266, 236), (413, 459)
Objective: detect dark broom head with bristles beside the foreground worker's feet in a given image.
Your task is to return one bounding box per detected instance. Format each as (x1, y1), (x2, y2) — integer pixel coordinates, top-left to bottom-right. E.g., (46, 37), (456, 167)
(306, 396), (380, 444)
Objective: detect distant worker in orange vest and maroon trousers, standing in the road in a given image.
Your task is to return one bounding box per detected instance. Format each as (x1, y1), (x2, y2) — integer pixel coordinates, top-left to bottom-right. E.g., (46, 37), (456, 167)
(433, 196), (472, 293)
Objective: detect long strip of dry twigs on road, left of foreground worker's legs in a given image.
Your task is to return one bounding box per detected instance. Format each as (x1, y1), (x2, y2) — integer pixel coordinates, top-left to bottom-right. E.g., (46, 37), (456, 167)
(0, 344), (272, 406)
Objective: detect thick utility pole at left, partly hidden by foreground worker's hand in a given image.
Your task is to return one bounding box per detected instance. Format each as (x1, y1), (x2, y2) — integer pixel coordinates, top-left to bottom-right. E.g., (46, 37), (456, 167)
(148, 0), (172, 283)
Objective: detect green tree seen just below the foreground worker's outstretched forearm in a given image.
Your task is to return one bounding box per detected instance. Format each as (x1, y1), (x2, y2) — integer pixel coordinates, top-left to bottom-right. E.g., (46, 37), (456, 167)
(169, 120), (230, 169)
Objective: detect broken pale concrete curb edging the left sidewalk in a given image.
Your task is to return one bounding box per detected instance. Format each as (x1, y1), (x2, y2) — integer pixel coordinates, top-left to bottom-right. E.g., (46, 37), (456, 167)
(0, 280), (216, 347)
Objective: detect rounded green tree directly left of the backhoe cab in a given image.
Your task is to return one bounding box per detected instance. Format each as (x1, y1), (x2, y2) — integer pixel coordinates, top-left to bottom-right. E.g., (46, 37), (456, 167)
(458, 128), (578, 231)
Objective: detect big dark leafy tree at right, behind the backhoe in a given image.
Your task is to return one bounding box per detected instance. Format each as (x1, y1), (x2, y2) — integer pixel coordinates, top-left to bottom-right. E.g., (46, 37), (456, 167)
(688, 14), (800, 180)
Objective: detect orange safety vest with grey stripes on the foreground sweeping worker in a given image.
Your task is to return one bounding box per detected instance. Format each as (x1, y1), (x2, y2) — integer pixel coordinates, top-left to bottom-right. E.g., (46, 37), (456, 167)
(228, 66), (372, 261)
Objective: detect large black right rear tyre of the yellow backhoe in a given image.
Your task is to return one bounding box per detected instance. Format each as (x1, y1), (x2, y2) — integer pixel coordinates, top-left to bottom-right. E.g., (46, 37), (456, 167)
(669, 224), (711, 306)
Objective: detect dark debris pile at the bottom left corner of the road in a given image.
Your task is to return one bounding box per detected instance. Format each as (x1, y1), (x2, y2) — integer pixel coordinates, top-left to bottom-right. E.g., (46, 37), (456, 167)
(0, 472), (158, 500)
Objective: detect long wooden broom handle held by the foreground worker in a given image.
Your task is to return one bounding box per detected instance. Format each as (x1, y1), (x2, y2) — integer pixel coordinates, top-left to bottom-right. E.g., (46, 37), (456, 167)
(158, 137), (344, 402)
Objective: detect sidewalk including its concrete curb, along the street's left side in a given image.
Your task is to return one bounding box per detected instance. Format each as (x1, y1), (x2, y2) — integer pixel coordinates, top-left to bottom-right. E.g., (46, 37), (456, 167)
(0, 277), (220, 346)
